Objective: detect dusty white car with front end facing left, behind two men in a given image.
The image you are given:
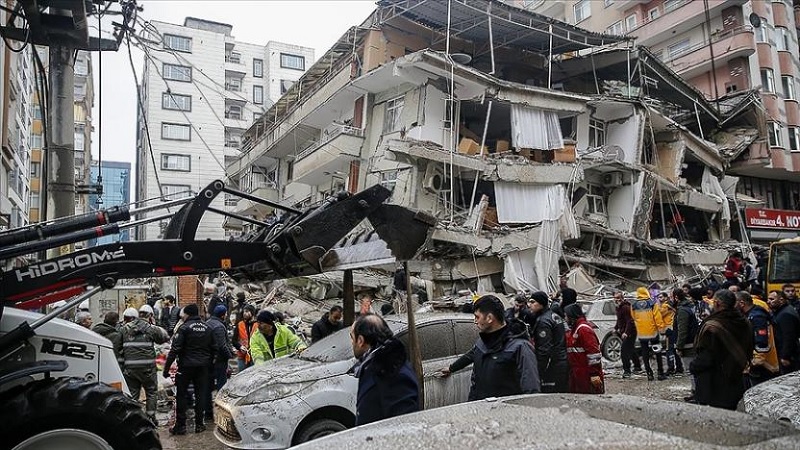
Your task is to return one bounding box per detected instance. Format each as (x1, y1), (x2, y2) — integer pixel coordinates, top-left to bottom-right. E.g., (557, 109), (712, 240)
(214, 314), (478, 449)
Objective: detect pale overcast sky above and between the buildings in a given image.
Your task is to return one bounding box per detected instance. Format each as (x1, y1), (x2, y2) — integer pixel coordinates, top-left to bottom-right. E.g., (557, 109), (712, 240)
(92, 0), (375, 185)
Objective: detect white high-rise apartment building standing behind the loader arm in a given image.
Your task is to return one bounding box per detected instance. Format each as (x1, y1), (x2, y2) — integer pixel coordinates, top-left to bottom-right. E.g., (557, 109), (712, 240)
(136, 17), (314, 243)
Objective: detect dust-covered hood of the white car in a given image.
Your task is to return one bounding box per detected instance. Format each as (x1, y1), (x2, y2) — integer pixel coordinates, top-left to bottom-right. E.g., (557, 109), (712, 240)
(220, 356), (355, 398)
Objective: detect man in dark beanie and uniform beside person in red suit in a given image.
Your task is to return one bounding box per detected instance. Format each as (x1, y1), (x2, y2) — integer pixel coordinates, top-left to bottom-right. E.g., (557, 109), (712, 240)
(528, 291), (569, 393)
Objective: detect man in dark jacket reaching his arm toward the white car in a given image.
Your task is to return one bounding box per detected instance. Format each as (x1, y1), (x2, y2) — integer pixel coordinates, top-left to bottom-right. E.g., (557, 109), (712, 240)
(441, 295), (540, 401)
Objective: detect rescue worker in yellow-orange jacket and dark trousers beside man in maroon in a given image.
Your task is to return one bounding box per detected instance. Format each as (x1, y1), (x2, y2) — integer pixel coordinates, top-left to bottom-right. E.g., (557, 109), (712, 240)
(631, 287), (666, 381)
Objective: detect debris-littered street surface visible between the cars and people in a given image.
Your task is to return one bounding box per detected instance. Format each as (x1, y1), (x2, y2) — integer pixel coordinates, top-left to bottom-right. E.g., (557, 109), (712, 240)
(159, 367), (691, 450)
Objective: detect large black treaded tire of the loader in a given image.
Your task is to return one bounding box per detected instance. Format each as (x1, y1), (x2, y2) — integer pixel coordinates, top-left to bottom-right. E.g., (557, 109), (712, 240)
(0, 378), (161, 450)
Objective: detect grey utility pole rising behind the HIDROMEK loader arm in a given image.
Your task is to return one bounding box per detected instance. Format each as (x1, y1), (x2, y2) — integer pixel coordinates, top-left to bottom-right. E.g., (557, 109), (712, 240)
(46, 40), (75, 258)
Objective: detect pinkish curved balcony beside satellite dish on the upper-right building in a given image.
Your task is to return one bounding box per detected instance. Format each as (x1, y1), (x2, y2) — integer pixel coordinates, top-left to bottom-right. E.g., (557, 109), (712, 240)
(668, 25), (756, 80)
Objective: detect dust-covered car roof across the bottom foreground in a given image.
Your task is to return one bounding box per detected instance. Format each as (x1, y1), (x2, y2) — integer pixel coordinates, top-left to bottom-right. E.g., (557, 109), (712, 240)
(297, 394), (800, 450)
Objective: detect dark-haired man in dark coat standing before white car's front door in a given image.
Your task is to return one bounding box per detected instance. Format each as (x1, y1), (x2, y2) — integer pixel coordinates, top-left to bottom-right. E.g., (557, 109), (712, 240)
(350, 314), (420, 426)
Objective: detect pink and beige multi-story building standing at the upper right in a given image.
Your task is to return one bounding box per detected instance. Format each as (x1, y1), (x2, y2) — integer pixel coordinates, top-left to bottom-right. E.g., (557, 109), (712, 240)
(520, 0), (800, 241)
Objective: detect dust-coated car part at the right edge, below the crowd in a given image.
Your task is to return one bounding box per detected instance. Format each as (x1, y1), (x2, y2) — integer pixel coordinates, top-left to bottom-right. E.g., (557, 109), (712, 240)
(742, 371), (800, 428)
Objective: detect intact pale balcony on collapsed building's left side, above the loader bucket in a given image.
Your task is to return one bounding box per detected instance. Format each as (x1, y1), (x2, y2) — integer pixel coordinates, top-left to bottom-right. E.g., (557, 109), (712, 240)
(293, 125), (364, 186)
